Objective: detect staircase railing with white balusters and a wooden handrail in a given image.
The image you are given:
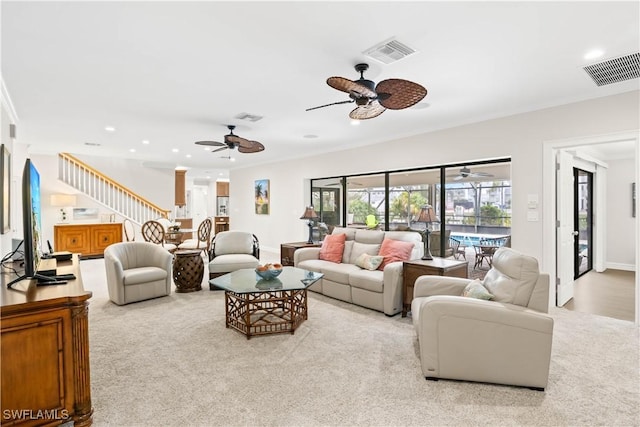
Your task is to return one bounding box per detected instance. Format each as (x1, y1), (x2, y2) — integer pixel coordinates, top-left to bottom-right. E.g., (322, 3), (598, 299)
(58, 153), (171, 225)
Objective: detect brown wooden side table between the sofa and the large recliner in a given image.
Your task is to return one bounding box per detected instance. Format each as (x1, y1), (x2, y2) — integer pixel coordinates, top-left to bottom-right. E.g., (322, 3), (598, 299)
(402, 257), (469, 317)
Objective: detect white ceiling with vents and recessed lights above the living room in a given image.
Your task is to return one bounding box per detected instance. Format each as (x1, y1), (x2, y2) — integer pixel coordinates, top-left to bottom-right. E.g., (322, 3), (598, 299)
(0, 0), (640, 178)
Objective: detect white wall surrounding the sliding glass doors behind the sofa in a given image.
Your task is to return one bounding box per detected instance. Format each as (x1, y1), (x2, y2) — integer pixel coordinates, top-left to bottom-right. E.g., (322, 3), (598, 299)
(230, 91), (640, 270)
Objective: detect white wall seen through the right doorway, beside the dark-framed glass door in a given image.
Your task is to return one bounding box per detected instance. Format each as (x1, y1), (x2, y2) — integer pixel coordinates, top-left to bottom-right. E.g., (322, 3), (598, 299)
(606, 159), (638, 270)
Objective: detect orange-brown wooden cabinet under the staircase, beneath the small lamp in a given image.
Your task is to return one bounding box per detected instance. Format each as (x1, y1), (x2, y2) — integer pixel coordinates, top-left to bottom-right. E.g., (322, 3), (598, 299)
(53, 222), (122, 258)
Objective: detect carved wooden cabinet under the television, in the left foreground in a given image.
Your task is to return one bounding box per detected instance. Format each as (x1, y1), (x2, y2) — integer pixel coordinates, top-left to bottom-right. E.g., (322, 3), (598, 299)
(0, 255), (93, 427)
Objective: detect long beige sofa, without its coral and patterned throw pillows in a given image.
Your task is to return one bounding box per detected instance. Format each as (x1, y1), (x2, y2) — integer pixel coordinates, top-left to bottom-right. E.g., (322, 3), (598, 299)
(294, 227), (424, 316)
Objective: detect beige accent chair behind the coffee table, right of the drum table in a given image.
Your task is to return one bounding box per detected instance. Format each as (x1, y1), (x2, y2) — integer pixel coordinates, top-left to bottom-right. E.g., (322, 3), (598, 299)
(209, 231), (260, 290)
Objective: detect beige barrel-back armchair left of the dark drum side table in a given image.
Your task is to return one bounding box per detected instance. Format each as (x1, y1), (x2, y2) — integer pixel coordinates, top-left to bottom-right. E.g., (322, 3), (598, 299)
(104, 242), (173, 305)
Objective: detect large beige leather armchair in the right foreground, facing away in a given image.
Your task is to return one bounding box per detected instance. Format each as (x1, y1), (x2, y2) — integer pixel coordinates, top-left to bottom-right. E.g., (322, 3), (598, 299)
(411, 247), (553, 390)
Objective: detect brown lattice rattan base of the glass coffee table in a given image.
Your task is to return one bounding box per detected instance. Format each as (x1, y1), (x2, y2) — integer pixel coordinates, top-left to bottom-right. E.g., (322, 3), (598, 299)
(224, 289), (307, 339)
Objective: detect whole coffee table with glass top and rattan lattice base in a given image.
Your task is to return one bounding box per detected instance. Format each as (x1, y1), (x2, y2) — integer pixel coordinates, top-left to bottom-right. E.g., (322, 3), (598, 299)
(209, 267), (323, 339)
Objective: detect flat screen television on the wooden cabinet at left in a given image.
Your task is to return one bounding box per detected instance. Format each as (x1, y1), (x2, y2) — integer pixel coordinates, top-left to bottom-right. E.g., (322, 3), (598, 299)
(7, 159), (55, 287)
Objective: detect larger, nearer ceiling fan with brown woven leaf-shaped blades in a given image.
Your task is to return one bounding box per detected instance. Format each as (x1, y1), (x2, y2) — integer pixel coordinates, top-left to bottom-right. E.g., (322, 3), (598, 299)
(306, 64), (427, 120)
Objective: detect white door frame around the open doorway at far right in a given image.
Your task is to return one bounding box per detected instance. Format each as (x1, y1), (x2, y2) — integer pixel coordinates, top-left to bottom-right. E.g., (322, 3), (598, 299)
(542, 130), (640, 324)
